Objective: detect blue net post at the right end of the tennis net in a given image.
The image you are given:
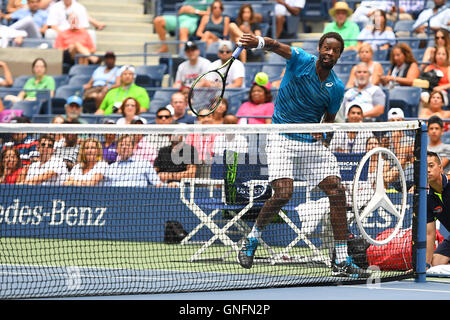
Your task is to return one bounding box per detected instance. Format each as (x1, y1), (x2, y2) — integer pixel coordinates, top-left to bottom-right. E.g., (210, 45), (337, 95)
(415, 121), (428, 283)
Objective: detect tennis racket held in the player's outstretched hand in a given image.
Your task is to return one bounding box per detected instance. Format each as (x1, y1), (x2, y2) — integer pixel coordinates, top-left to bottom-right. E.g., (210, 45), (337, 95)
(188, 46), (243, 116)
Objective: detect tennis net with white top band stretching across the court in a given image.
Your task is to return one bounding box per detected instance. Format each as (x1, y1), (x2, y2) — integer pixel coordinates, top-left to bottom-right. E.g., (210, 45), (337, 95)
(0, 121), (426, 298)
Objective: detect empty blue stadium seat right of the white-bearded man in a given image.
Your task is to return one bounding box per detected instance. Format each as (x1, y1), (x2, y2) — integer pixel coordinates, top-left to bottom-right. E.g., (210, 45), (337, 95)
(389, 87), (422, 118)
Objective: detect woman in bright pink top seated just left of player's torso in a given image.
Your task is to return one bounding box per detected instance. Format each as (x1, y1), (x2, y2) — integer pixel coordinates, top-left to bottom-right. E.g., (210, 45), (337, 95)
(236, 82), (274, 124)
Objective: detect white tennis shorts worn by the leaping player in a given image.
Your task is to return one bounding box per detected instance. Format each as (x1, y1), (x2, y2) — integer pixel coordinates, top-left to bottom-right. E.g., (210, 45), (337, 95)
(266, 133), (341, 187)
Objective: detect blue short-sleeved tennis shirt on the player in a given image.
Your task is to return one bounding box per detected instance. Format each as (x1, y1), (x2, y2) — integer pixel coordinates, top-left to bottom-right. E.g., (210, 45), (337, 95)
(272, 47), (344, 142)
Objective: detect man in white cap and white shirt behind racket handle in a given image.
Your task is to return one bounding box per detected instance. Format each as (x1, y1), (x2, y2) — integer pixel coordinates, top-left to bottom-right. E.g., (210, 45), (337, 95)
(209, 40), (245, 88)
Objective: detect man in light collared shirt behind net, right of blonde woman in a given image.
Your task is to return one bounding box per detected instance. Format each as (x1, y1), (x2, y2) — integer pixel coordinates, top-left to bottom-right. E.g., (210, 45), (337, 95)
(105, 135), (162, 187)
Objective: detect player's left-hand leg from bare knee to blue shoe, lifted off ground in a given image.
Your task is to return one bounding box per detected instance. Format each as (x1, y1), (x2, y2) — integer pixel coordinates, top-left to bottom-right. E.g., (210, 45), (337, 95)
(238, 178), (294, 269)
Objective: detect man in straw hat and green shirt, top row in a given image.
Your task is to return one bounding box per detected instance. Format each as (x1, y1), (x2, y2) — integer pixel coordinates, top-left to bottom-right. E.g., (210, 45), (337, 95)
(323, 1), (360, 50)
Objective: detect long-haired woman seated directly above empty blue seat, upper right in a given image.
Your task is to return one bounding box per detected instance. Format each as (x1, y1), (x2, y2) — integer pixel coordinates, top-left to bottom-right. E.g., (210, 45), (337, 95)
(380, 42), (420, 89)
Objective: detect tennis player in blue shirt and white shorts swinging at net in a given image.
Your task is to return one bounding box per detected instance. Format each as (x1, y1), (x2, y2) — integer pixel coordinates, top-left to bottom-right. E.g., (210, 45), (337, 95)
(238, 32), (369, 278)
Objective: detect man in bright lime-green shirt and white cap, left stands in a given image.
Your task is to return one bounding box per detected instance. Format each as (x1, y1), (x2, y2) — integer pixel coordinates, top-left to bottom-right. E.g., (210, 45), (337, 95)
(95, 65), (150, 115)
